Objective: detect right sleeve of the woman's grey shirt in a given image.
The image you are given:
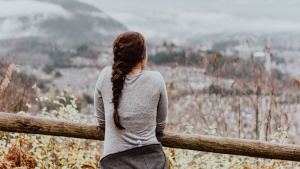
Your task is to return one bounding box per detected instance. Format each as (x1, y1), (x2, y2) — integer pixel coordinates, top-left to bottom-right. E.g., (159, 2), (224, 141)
(156, 74), (168, 133)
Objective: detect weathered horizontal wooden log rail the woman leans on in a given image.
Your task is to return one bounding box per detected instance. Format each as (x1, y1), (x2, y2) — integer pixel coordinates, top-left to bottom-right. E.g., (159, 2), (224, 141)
(0, 112), (300, 161)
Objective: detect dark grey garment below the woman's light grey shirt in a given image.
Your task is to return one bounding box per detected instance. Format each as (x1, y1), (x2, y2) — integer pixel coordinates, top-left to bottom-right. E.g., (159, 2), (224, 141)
(100, 144), (169, 169)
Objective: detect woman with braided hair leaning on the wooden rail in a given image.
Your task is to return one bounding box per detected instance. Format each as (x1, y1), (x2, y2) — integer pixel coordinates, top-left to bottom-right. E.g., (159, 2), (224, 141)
(94, 32), (169, 169)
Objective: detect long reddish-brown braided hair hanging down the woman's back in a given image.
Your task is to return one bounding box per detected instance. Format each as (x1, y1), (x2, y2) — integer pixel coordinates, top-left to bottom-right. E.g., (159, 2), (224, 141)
(111, 32), (146, 130)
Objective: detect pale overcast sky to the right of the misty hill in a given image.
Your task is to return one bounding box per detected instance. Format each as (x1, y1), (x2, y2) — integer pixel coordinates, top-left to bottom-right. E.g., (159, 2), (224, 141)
(75, 0), (300, 41)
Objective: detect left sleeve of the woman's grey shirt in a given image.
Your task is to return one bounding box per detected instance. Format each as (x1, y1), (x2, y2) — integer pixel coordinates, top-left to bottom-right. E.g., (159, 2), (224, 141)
(94, 68), (107, 129)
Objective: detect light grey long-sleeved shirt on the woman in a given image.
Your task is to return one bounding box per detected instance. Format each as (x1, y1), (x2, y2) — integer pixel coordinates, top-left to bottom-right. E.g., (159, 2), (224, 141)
(94, 66), (168, 158)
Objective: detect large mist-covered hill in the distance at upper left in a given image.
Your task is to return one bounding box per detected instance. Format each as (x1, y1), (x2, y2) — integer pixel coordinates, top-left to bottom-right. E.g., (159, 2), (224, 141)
(0, 0), (127, 46)
